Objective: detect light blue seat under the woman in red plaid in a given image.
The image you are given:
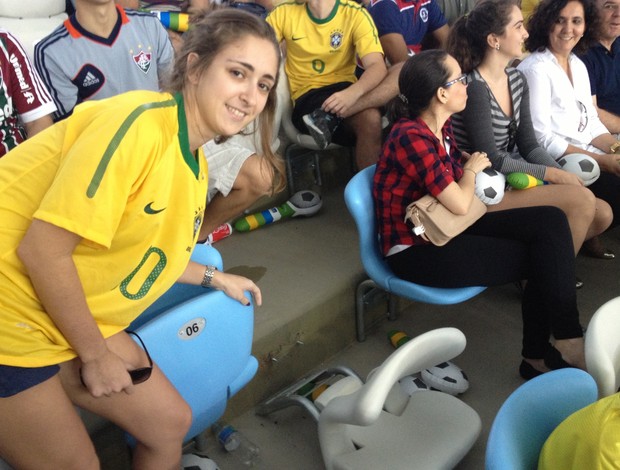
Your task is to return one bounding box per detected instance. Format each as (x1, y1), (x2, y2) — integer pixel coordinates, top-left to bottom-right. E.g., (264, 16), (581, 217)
(344, 165), (485, 341)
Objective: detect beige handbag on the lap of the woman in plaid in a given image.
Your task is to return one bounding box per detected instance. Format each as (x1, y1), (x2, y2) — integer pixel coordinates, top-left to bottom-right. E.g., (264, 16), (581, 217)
(405, 194), (487, 246)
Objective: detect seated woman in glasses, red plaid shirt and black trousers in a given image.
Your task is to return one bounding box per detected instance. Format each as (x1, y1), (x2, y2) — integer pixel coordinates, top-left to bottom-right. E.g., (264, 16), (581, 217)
(374, 50), (585, 379)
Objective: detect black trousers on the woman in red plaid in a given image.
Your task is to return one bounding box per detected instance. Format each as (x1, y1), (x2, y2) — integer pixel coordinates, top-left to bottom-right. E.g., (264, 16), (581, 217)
(387, 206), (583, 359)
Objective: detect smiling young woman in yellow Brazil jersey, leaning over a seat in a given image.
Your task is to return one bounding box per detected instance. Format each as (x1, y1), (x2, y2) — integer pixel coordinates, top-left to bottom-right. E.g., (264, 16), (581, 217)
(0, 9), (280, 470)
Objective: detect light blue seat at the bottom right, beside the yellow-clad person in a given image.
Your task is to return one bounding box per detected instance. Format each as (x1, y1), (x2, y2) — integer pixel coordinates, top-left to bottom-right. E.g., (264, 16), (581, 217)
(486, 368), (598, 470)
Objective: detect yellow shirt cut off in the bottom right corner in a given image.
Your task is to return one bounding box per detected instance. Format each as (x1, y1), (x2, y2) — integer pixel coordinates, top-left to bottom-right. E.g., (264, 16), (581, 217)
(538, 393), (620, 470)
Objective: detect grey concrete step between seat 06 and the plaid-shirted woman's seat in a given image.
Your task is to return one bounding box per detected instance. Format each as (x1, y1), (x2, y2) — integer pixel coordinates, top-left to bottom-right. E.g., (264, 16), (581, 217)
(215, 172), (376, 418)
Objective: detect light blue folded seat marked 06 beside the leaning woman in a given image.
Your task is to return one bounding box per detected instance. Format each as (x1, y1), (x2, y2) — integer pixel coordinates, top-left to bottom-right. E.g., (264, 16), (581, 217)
(129, 245), (258, 441)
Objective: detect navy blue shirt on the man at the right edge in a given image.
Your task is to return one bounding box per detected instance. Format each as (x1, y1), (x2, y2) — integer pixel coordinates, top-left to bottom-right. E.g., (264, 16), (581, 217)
(581, 38), (620, 116)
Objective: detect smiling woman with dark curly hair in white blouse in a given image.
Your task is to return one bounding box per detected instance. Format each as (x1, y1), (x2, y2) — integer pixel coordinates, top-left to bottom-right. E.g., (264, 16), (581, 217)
(518, 0), (620, 255)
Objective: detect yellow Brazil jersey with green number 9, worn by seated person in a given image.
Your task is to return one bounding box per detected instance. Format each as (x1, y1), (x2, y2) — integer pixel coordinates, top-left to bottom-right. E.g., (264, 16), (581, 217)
(267, 0), (383, 100)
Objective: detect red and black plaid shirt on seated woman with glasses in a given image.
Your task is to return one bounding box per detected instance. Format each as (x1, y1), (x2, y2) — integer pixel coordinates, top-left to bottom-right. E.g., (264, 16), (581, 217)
(373, 118), (463, 254)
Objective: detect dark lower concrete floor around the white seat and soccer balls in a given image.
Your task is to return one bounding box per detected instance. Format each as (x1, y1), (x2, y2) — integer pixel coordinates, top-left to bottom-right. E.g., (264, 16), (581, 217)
(193, 199), (620, 470)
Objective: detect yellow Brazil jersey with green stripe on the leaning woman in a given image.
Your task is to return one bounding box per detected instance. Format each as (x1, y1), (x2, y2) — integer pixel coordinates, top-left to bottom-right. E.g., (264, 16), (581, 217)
(0, 91), (207, 367)
